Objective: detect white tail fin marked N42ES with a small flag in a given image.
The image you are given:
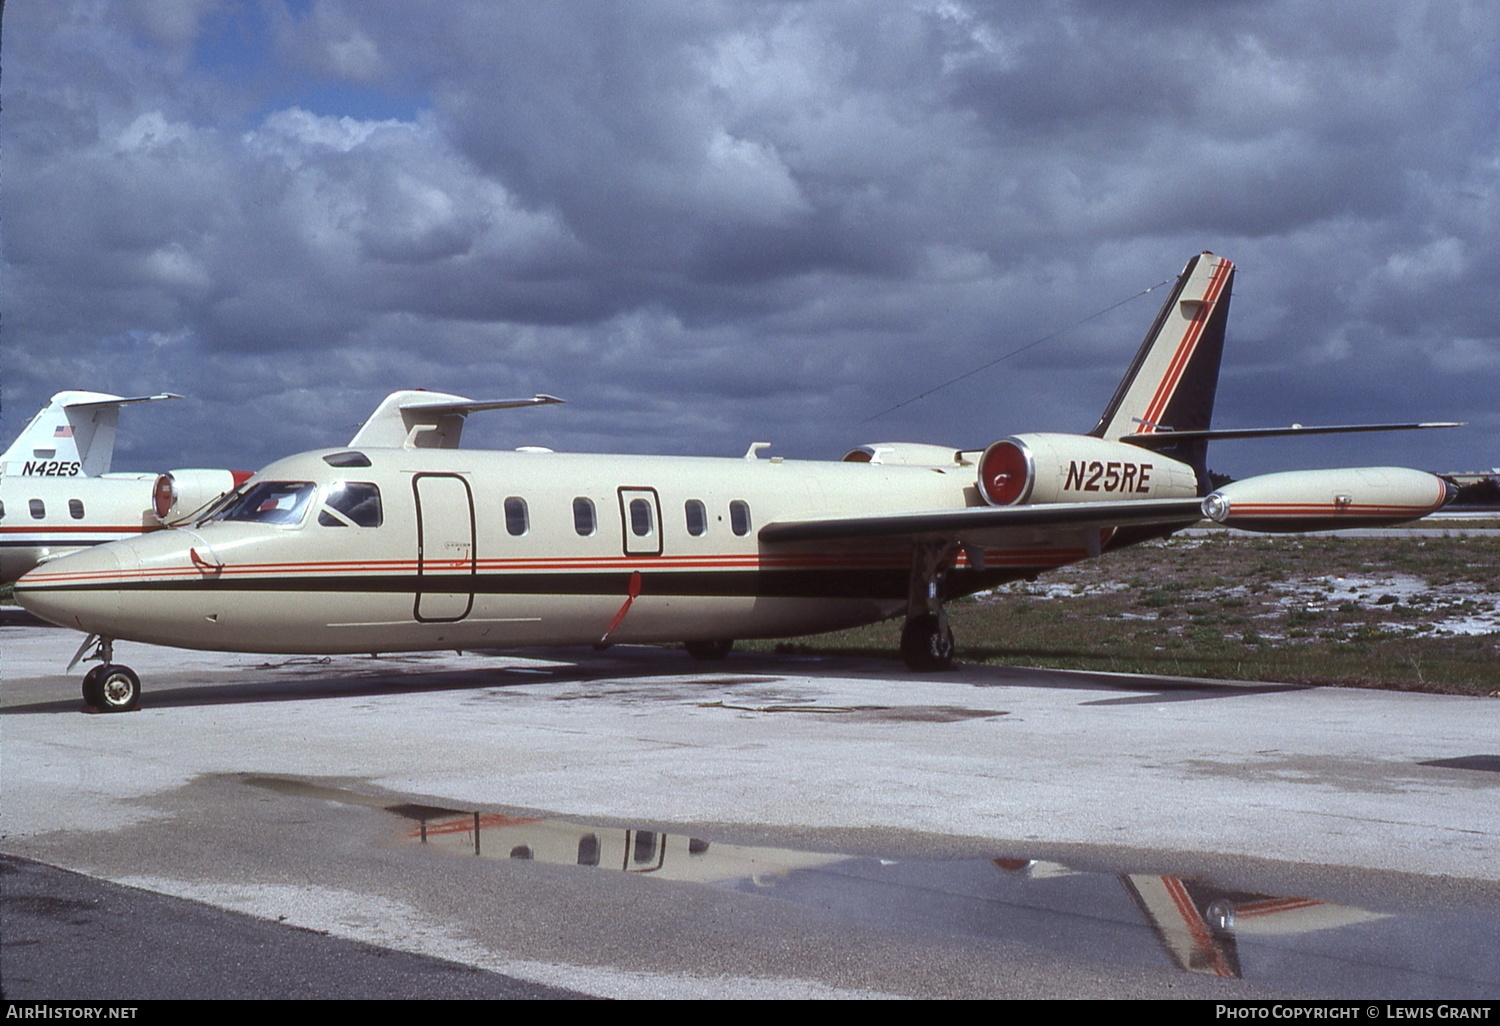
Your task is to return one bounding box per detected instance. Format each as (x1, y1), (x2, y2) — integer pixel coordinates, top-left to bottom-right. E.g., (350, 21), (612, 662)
(0, 392), (182, 477)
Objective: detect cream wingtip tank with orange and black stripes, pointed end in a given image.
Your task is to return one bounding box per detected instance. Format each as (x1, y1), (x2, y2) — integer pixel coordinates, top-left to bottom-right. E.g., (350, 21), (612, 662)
(1203, 467), (1457, 533)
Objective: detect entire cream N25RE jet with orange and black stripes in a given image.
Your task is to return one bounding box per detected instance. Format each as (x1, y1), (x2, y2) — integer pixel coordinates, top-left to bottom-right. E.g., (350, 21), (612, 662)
(15, 254), (1454, 710)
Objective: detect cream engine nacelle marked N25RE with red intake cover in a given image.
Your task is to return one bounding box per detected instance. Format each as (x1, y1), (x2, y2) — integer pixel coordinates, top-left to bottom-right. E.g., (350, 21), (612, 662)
(978, 434), (1199, 506)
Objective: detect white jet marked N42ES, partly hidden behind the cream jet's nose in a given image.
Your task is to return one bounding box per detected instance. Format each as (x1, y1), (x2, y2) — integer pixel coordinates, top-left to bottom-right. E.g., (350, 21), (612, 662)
(0, 392), (249, 584)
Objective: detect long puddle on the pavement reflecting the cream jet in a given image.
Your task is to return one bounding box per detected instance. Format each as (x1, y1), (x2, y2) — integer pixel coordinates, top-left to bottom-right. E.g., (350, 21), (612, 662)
(392, 807), (1500, 998)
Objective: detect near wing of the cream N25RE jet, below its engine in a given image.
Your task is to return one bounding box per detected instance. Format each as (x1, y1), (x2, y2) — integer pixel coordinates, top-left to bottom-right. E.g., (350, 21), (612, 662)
(759, 498), (1203, 543)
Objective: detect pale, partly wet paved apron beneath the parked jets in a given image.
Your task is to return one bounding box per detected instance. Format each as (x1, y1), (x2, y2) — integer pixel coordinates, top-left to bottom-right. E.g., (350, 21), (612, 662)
(0, 614), (1500, 1001)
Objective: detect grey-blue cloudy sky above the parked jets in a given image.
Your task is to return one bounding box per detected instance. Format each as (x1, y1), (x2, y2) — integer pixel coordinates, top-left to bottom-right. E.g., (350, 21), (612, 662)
(0, 0), (1500, 476)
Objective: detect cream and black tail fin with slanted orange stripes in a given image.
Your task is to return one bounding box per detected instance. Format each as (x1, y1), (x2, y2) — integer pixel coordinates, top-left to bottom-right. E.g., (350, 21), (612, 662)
(1089, 254), (1235, 480)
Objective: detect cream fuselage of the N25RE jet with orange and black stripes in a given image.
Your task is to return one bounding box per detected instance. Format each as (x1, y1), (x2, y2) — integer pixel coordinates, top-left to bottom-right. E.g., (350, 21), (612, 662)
(11, 449), (1146, 653)
